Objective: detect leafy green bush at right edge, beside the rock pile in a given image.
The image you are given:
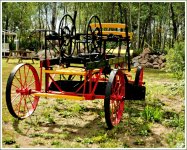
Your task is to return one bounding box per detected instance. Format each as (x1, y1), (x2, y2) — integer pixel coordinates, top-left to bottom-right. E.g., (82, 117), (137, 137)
(166, 42), (185, 79)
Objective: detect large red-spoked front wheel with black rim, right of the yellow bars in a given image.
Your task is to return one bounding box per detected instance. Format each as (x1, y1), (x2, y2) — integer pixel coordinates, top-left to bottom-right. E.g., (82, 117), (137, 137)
(104, 69), (125, 129)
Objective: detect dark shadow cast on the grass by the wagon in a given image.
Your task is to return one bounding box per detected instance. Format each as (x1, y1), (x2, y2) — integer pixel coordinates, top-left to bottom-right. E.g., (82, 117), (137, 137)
(10, 99), (167, 148)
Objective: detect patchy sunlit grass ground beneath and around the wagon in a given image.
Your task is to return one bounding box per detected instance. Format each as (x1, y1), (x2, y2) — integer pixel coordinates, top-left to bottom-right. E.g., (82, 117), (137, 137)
(2, 59), (185, 148)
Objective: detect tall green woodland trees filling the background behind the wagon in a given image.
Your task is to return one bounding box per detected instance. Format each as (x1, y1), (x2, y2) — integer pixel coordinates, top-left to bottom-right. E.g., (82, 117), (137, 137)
(2, 2), (185, 50)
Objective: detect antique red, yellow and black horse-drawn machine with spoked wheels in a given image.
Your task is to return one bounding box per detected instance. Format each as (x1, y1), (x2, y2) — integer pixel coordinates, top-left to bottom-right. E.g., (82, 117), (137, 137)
(6, 13), (145, 129)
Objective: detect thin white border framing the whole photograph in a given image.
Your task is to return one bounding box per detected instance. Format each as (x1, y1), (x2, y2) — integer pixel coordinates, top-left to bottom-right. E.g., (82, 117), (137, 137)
(0, 0), (187, 150)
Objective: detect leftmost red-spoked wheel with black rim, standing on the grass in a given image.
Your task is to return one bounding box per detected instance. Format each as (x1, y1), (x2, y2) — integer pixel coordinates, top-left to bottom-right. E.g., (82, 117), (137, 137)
(6, 64), (41, 119)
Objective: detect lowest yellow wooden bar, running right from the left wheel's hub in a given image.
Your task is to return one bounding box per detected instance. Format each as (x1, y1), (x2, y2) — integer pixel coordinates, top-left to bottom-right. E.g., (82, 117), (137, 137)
(32, 93), (85, 100)
